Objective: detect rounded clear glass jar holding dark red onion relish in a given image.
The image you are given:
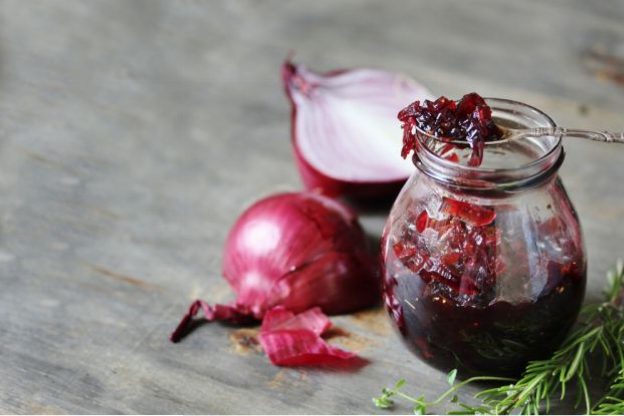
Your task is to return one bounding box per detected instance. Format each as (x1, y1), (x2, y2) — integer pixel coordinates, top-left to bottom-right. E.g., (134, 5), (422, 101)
(382, 99), (587, 375)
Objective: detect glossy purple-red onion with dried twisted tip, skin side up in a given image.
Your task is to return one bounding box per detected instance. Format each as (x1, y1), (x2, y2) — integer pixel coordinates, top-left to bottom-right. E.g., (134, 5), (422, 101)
(170, 193), (380, 342)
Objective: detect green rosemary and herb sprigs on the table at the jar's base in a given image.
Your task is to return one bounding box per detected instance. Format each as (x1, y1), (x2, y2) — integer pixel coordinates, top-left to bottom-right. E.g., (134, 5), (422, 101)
(373, 261), (624, 415)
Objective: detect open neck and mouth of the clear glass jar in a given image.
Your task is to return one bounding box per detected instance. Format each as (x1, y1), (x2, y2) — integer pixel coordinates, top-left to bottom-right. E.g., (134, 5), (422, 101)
(413, 98), (565, 195)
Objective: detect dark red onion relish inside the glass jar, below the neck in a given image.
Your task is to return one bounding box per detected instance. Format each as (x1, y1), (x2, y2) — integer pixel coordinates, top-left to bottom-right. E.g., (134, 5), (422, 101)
(384, 198), (586, 376)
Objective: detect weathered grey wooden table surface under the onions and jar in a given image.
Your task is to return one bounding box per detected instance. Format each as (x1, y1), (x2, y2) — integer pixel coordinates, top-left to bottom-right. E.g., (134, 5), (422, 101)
(0, 0), (624, 413)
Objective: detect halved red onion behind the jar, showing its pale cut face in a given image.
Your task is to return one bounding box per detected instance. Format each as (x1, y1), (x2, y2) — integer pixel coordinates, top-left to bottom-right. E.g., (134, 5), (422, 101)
(282, 61), (432, 199)
